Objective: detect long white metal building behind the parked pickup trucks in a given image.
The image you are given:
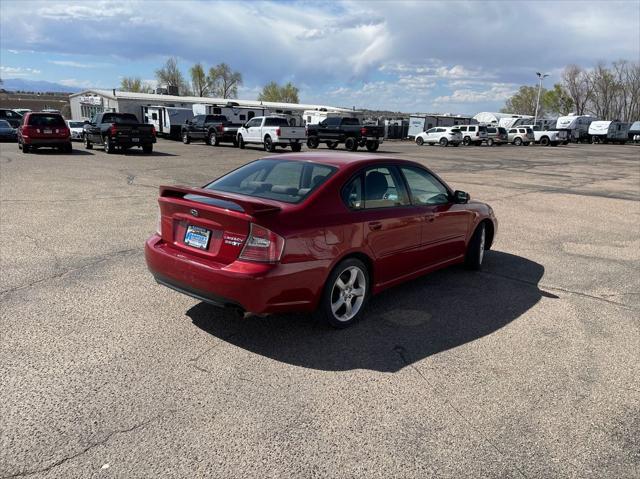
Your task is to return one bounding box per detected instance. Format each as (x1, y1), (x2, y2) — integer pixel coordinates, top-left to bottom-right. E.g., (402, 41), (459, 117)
(69, 90), (353, 122)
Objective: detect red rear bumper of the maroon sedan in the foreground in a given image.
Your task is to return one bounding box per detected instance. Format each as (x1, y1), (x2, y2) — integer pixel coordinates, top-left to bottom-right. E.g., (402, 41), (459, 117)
(145, 235), (329, 314)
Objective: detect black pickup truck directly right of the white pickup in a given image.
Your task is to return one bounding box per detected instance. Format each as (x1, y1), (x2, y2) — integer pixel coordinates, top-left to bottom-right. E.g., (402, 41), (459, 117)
(307, 116), (384, 151)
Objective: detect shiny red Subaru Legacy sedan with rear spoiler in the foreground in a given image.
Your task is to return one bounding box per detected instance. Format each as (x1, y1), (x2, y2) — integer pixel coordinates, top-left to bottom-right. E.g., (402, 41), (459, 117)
(145, 153), (497, 327)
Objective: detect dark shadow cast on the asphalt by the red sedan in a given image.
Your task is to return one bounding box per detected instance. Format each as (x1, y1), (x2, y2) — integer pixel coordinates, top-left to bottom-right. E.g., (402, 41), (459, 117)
(187, 251), (556, 372)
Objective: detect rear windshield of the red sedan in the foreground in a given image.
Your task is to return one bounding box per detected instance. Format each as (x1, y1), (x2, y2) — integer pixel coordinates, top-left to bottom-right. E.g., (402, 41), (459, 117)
(205, 159), (336, 203)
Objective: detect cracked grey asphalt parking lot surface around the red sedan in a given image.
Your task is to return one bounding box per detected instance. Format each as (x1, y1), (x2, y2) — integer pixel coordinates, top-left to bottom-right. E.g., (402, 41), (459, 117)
(0, 140), (640, 478)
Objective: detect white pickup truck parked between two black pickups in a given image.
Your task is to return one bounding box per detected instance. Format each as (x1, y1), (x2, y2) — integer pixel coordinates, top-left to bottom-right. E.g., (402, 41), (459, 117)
(238, 116), (307, 151)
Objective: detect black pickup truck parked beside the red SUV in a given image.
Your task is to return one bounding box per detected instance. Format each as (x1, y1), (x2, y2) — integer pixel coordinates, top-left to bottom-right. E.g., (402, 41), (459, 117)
(82, 113), (156, 153)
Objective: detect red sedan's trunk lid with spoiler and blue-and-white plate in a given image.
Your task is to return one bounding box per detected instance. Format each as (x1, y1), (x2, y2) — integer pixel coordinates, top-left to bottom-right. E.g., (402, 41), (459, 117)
(158, 186), (280, 264)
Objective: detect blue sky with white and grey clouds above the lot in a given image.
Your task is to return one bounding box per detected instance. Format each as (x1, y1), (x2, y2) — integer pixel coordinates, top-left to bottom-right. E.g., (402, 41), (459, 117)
(0, 0), (640, 114)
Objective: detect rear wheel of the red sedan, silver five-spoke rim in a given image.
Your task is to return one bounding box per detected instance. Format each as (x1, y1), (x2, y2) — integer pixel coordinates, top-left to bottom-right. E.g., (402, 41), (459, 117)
(320, 258), (370, 329)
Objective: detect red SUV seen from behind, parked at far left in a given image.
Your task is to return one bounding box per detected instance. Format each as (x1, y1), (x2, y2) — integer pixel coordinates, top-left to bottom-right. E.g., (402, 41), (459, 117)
(18, 112), (73, 153)
